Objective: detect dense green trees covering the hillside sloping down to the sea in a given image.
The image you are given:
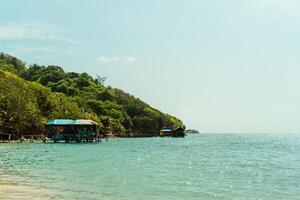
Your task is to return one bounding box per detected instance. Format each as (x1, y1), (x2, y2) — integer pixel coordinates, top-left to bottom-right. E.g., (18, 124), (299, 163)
(0, 53), (183, 136)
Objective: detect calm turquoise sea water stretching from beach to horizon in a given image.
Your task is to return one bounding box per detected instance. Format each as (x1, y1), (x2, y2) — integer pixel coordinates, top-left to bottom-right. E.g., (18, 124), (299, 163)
(0, 134), (300, 200)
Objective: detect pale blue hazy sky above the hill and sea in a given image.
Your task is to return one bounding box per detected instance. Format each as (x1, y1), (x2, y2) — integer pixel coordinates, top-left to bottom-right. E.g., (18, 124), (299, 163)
(0, 0), (300, 133)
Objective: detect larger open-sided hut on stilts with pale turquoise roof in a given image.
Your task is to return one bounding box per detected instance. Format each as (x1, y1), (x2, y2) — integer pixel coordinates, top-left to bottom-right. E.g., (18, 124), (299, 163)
(46, 119), (101, 142)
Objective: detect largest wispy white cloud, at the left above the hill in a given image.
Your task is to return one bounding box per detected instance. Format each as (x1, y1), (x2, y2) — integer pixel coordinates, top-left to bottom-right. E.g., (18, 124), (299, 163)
(0, 23), (81, 44)
